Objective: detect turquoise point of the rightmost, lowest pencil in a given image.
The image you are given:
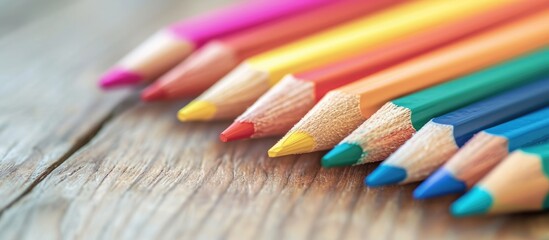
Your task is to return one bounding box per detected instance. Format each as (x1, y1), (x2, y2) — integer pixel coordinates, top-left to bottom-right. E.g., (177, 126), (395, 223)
(450, 187), (494, 217)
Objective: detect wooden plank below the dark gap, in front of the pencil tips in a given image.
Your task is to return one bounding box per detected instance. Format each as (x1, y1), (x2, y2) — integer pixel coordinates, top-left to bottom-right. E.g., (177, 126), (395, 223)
(0, 103), (549, 239)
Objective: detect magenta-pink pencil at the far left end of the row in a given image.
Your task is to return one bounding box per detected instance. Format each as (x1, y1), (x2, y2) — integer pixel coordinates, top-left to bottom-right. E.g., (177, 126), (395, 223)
(99, 0), (330, 89)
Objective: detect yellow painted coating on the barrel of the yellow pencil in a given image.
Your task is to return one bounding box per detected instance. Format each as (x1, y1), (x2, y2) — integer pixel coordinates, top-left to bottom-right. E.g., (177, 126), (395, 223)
(248, 0), (510, 85)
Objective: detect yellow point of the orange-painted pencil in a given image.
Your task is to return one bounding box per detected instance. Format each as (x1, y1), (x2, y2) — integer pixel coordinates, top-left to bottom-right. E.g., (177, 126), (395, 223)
(269, 132), (315, 157)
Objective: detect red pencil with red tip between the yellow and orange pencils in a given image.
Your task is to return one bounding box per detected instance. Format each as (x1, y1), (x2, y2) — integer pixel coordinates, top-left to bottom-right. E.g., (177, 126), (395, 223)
(220, 1), (548, 141)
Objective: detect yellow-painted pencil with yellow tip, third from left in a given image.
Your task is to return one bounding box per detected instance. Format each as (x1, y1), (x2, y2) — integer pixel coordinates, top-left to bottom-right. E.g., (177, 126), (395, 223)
(178, 0), (509, 121)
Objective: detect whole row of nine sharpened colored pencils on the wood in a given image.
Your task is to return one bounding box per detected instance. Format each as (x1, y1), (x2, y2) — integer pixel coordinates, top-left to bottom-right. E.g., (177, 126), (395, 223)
(100, 0), (549, 216)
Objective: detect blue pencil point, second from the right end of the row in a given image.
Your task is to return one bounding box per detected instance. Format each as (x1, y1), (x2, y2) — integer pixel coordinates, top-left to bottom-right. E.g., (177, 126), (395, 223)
(414, 168), (467, 199)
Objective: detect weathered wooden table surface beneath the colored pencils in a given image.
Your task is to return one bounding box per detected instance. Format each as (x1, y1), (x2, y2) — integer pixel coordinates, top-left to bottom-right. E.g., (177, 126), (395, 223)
(0, 0), (549, 239)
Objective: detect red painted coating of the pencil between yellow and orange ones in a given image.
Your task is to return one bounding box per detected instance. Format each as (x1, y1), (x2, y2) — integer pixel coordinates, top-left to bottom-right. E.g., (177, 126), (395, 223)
(302, 1), (549, 98)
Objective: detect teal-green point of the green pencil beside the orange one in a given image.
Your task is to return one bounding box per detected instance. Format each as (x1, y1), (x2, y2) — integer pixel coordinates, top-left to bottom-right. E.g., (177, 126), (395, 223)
(321, 143), (363, 168)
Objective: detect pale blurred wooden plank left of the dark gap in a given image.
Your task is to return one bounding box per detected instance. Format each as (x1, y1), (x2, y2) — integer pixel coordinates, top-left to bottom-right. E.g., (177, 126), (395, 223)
(0, 0), (227, 210)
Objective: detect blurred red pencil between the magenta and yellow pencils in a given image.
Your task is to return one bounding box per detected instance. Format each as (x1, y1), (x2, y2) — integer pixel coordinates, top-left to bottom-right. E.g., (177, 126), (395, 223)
(141, 0), (402, 101)
